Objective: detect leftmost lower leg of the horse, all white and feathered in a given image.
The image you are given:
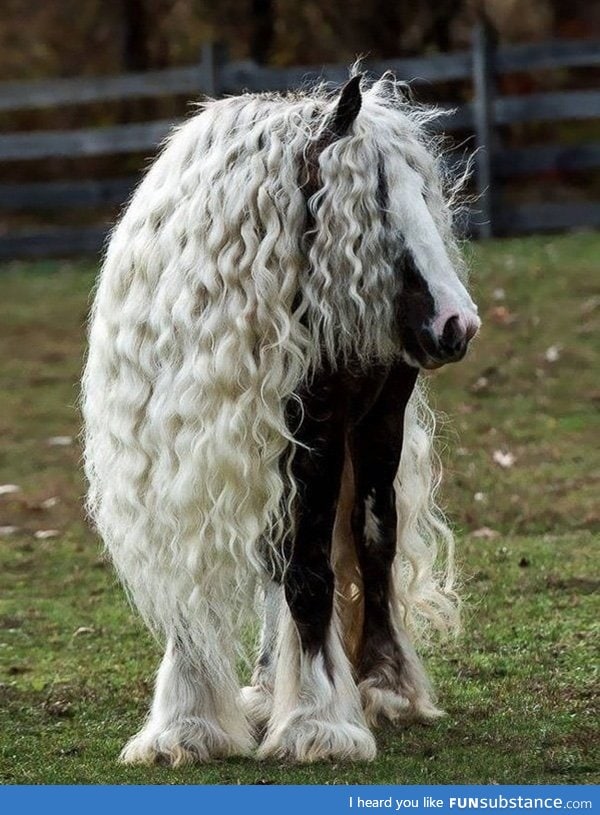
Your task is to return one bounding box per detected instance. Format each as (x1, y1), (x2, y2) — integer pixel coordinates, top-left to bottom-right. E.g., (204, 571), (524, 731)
(121, 632), (254, 766)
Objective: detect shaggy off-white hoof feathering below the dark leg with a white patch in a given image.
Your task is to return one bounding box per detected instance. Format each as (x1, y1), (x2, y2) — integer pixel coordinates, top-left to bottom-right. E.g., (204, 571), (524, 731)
(358, 679), (445, 727)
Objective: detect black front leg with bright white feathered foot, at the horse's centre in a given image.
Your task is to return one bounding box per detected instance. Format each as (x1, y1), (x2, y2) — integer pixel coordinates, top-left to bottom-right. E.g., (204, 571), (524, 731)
(260, 377), (375, 761)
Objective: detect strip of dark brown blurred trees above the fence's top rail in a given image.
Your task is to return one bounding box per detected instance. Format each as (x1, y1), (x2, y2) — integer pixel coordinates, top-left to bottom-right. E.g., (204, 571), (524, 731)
(0, 0), (600, 73)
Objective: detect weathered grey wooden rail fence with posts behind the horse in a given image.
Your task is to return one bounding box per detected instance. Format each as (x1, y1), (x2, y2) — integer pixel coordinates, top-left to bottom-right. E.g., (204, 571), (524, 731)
(0, 23), (600, 259)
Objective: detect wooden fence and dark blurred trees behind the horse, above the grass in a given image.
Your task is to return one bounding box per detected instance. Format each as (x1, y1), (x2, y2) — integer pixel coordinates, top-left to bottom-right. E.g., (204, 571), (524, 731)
(0, 0), (600, 253)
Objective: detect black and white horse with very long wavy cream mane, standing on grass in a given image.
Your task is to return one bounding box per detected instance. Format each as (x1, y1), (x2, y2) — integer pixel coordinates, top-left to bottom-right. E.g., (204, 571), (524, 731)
(82, 74), (479, 766)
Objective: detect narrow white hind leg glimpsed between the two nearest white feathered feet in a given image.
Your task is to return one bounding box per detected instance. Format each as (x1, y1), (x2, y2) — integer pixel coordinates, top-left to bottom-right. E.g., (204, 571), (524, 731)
(241, 577), (285, 736)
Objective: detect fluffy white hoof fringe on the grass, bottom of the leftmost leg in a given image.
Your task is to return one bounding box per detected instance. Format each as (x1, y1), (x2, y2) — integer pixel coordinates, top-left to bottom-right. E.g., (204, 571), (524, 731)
(120, 718), (254, 767)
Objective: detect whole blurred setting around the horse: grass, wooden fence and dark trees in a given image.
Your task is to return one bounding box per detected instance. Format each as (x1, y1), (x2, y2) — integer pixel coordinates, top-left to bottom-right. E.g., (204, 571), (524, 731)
(0, 0), (600, 784)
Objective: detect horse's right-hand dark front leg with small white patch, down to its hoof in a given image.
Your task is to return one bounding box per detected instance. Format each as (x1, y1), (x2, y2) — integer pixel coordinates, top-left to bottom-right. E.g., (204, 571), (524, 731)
(350, 363), (439, 724)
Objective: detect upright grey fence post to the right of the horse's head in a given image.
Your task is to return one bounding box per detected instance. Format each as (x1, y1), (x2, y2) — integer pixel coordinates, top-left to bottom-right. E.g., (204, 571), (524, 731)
(472, 16), (496, 238)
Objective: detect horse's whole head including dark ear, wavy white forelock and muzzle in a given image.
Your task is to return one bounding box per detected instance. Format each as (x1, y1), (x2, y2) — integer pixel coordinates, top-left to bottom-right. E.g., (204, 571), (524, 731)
(314, 76), (480, 368)
